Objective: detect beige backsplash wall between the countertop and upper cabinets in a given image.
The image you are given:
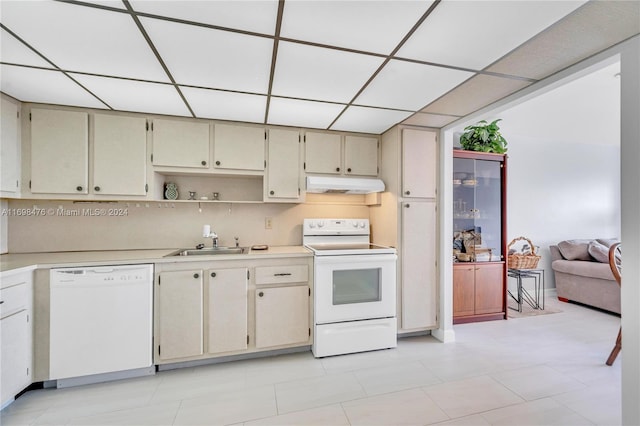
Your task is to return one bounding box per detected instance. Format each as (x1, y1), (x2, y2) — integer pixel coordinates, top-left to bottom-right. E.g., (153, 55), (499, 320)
(8, 195), (369, 253)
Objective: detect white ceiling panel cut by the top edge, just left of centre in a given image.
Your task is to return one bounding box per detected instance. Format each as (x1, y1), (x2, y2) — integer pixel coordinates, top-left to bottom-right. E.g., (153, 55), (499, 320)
(131, 0), (278, 35)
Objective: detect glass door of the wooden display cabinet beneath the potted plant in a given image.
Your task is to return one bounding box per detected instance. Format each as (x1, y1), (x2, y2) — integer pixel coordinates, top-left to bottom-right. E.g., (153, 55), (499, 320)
(453, 158), (503, 262)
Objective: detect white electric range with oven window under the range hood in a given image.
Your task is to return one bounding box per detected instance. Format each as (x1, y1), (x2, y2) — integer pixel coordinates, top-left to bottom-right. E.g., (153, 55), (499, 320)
(302, 219), (397, 357)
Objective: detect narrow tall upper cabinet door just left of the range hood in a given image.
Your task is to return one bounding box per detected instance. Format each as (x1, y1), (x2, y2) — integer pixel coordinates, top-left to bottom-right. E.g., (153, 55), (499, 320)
(265, 129), (300, 201)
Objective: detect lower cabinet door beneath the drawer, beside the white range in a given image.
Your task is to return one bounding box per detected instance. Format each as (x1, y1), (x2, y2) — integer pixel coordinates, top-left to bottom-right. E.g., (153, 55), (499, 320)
(256, 285), (310, 348)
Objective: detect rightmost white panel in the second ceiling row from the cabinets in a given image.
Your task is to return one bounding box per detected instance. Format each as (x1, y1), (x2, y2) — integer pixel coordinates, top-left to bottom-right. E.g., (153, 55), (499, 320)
(354, 60), (473, 111)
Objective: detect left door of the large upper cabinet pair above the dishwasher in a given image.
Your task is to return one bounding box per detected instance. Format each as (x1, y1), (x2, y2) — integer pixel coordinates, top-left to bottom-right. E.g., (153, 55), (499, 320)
(31, 108), (89, 194)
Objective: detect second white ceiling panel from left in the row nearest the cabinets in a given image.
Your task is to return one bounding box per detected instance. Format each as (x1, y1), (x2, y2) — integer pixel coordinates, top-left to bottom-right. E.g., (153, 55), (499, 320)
(72, 74), (191, 116)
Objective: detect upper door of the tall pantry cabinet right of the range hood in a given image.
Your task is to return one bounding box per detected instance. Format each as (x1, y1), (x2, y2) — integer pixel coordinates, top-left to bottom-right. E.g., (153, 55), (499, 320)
(402, 129), (438, 198)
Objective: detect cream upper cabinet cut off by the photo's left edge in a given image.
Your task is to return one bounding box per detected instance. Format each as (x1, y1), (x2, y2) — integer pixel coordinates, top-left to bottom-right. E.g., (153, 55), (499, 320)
(0, 96), (20, 197)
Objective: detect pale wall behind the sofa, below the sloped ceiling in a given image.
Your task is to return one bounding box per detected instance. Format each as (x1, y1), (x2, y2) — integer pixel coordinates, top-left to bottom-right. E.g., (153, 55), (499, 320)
(507, 135), (620, 287)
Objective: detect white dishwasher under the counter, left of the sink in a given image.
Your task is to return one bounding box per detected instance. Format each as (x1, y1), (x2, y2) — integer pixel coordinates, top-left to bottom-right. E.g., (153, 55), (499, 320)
(49, 265), (153, 387)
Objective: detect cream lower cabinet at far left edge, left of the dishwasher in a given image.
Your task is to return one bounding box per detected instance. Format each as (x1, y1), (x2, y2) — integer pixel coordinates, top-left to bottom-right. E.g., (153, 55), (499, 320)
(0, 272), (33, 408)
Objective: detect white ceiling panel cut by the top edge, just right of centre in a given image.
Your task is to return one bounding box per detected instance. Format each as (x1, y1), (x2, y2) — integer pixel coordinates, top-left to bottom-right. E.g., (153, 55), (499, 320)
(280, 1), (433, 54)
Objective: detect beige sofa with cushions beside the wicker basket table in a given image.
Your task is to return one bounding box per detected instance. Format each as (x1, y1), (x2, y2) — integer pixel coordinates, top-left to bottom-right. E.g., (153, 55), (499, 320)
(549, 239), (620, 314)
